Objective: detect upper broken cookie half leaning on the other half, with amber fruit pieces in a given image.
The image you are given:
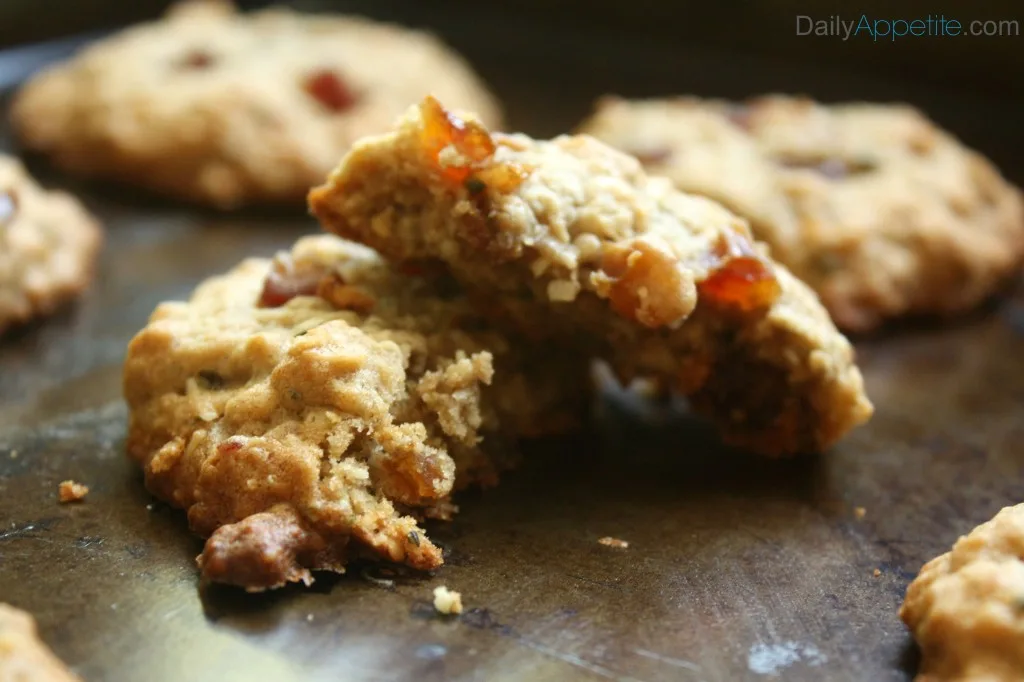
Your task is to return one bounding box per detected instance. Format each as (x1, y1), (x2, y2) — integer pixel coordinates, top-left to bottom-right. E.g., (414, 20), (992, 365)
(309, 98), (871, 455)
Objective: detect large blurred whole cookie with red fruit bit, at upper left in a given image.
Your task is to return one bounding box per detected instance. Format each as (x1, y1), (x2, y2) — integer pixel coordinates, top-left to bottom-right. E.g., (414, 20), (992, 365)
(12, 0), (500, 209)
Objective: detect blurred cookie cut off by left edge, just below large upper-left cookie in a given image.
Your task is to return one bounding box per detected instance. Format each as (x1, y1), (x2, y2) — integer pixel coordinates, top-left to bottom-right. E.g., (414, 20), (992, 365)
(0, 155), (102, 333)
